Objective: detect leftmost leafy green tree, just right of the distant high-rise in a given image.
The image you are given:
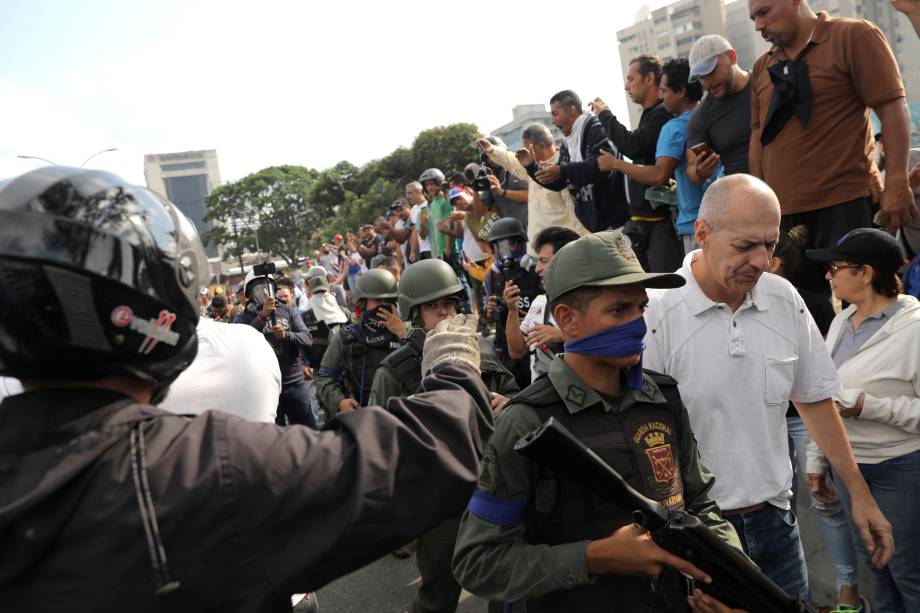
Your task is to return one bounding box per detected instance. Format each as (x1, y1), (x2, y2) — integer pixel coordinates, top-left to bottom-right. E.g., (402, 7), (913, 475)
(202, 166), (333, 266)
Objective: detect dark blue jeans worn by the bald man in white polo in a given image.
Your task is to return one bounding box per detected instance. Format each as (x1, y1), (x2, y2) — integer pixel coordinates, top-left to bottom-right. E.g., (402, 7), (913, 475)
(725, 504), (808, 598)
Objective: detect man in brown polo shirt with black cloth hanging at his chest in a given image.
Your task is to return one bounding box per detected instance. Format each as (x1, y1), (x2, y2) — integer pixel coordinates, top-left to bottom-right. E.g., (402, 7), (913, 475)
(748, 0), (917, 295)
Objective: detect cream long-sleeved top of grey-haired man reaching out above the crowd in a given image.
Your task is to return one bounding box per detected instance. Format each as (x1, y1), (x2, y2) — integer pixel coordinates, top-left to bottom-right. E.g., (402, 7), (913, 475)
(489, 147), (590, 255)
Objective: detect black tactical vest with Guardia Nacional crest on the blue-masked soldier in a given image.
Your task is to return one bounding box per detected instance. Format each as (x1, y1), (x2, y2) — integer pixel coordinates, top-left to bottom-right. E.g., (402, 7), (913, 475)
(511, 371), (688, 613)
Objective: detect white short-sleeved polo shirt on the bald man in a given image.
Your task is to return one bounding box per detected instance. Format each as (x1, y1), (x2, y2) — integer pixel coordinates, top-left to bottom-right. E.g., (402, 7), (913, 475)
(643, 250), (839, 509)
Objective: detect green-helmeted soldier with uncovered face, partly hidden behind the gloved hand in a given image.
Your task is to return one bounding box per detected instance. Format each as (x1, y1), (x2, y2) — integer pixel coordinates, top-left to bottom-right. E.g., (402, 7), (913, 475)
(370, 260), (518, 613)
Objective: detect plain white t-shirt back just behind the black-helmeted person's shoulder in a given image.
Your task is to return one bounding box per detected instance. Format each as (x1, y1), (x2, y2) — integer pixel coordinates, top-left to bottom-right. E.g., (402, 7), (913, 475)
(159, 318), (281, 423)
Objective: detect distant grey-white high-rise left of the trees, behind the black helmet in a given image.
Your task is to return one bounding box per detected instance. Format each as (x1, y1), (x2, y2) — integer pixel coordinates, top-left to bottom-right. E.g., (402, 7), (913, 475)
(144, 149), (220, 258)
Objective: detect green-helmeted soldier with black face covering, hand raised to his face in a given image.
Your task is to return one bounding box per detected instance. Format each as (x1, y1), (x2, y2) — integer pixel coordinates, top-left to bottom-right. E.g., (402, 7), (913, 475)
(316, 268), (406, 419)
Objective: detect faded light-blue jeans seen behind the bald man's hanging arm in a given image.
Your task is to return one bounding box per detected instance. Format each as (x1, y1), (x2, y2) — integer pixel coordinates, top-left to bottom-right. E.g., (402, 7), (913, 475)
(786, 415), (859, 594)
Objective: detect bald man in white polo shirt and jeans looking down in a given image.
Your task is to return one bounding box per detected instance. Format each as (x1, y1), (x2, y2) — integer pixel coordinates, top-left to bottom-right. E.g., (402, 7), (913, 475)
(643, 174), (893, 597)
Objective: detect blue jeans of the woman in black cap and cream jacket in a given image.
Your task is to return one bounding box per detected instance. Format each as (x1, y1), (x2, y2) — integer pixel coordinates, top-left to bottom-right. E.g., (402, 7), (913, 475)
(837, 451), (920, 613)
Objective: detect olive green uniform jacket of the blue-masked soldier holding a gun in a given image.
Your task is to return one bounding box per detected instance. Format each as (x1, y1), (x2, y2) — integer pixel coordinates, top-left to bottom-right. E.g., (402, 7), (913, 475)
(453, 357), (741, 602)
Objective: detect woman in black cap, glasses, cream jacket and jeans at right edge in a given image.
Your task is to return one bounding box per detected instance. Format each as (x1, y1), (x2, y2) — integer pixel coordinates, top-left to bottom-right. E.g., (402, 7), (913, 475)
(806, 228), (920, 611)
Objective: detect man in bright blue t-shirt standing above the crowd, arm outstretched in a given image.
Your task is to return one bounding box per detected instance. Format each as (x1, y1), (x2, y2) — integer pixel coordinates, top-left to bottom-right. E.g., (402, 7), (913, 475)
(598, 58), (721, 253)
